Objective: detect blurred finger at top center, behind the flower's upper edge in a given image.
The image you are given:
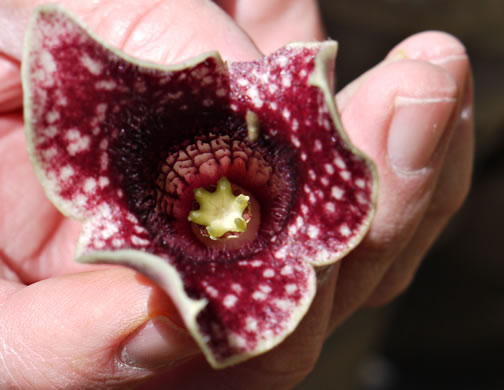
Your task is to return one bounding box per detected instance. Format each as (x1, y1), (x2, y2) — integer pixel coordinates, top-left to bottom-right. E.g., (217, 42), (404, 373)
(215, 0), (326, 53)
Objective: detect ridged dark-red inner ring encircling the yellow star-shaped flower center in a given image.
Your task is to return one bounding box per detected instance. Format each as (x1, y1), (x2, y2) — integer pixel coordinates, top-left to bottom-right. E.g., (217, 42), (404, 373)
(153, 132), (294, 260)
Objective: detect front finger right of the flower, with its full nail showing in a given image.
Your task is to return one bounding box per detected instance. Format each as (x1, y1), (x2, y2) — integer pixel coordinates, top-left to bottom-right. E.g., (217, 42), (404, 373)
(333, 60), (458, 326)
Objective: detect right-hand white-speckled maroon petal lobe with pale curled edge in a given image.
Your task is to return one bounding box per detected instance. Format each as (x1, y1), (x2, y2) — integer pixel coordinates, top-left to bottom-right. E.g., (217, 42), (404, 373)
(231, 41), (377, 265)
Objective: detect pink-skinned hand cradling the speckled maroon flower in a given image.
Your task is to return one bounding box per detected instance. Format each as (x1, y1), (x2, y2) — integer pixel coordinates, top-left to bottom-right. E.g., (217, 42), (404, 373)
(0, 1), (472, 389)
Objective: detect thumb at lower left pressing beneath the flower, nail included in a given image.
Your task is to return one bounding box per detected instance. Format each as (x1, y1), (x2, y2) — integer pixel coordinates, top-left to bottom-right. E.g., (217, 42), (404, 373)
(0, 268), (199, 389)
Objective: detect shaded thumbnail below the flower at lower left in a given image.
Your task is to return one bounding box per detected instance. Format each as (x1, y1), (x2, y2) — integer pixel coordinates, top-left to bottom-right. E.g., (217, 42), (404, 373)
(119, 317), (199, 369)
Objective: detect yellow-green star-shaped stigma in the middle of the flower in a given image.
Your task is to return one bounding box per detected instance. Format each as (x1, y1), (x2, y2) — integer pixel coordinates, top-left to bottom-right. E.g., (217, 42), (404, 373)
(187, 177), (250, 240)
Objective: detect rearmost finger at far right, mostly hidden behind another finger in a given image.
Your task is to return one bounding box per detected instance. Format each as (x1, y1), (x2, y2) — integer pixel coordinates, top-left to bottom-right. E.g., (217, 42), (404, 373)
(367, 33), (474, 306)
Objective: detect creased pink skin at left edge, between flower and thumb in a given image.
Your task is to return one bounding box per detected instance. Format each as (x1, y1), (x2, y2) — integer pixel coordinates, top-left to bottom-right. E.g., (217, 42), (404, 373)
(0, 114), (91, 283)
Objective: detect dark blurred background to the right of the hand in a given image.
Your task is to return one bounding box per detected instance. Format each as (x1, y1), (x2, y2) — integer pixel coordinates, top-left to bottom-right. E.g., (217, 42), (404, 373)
(296, 0), (504, 390)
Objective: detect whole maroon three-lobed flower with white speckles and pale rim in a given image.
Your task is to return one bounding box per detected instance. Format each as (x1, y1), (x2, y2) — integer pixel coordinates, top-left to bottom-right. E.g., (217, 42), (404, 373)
(23, 6), (376, 368)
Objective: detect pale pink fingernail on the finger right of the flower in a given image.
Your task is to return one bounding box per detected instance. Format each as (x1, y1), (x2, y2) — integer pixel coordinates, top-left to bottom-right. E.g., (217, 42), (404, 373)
(388, 96), (456, 172)
